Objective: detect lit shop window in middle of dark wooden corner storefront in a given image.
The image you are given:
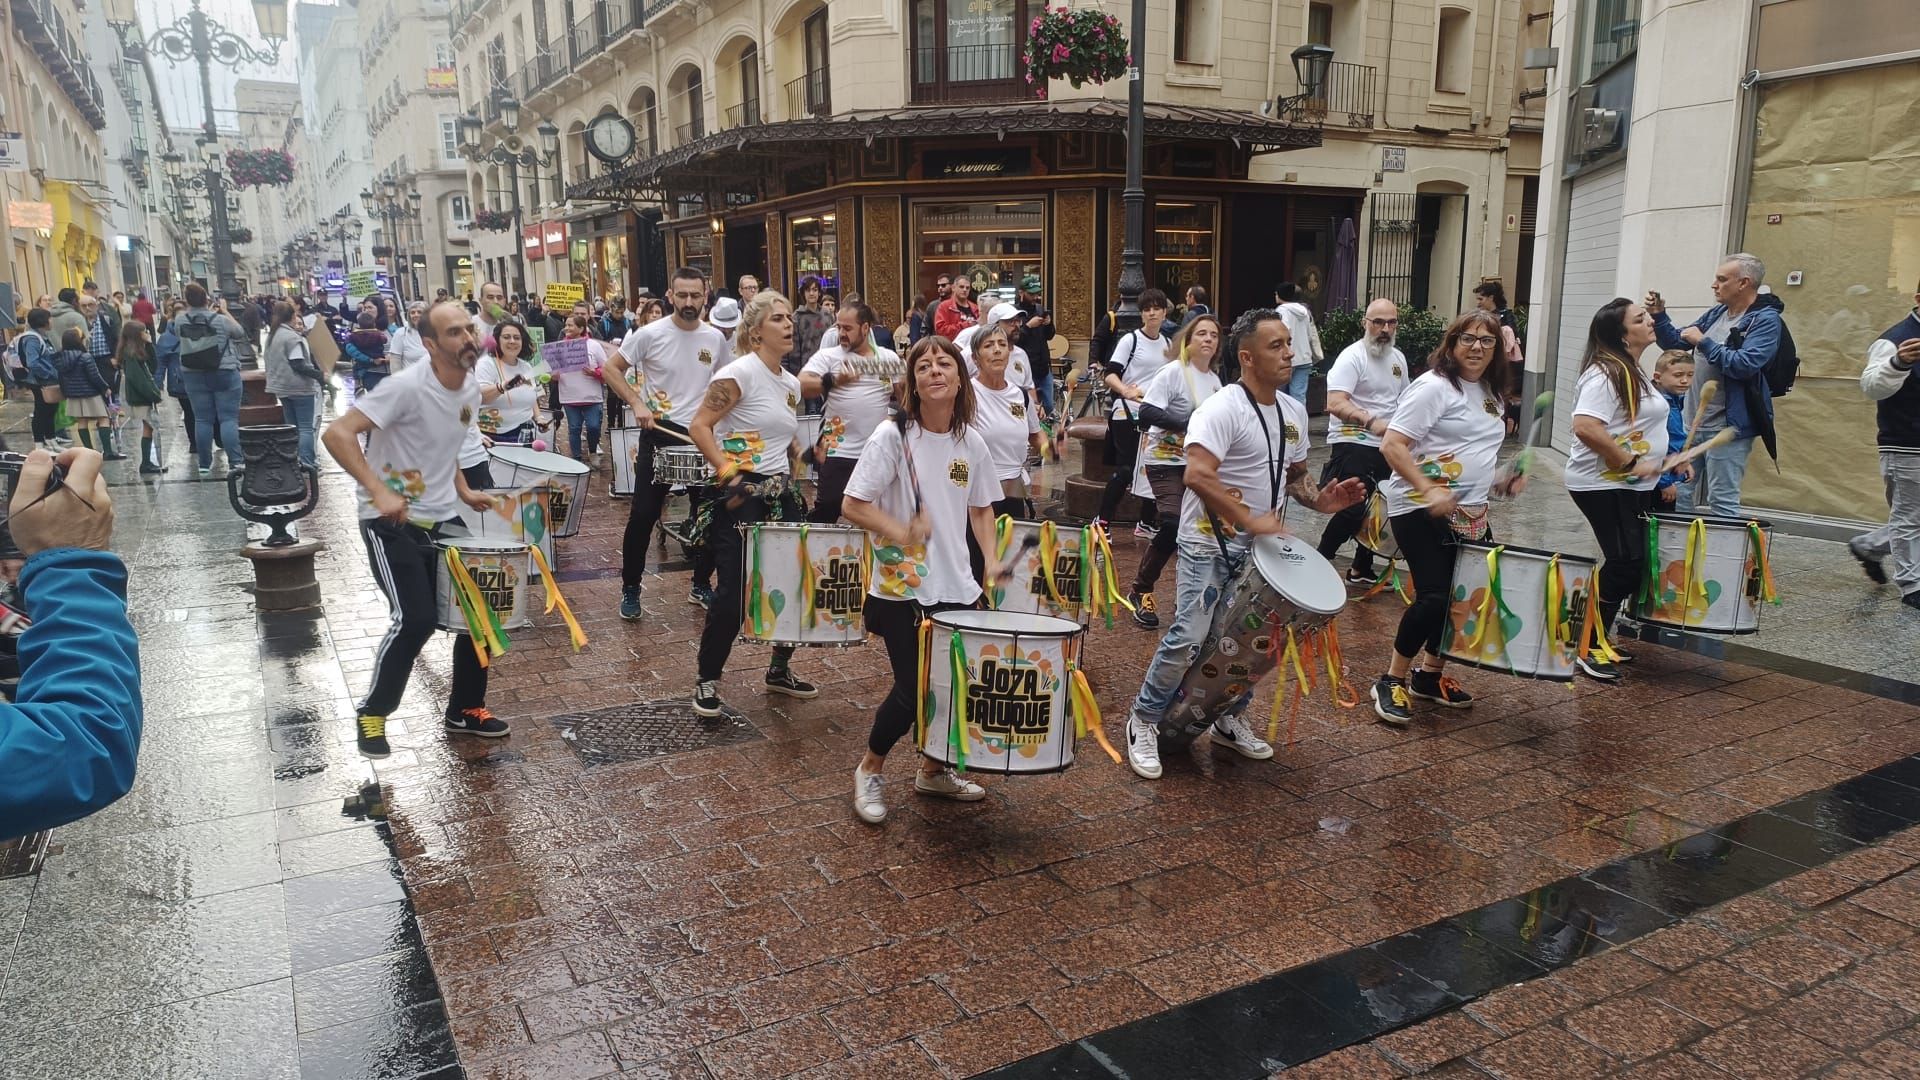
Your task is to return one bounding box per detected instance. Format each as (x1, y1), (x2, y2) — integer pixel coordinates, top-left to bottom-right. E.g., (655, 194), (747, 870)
(912, 200), (1046, 300)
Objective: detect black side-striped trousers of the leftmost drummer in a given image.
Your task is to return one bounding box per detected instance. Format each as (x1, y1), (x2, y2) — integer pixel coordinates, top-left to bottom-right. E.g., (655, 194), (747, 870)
(359, 519), (486, 717)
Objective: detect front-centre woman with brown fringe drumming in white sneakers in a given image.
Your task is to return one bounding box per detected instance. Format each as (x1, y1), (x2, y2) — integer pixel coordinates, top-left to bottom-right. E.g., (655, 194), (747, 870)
(848, 332), (1006, 824)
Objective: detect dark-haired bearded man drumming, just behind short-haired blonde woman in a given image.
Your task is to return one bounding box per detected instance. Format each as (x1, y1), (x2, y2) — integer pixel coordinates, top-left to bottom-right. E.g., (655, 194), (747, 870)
(607, 267), (730, 623)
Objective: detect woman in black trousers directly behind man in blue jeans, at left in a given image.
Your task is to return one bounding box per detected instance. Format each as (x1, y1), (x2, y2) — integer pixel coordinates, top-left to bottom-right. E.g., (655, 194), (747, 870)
(1127, 315), (1219, 630)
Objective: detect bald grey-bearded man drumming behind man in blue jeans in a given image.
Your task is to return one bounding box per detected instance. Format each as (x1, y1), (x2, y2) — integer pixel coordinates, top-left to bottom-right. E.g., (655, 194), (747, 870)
(1319, 300), (1407, 586)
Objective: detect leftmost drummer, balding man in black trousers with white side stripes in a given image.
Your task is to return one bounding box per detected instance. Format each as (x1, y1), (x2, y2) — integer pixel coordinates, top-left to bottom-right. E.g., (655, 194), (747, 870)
(321, 300), (509, 757)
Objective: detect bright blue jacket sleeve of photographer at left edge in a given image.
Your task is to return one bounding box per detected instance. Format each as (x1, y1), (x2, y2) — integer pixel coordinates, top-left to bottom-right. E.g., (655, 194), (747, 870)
(0, 548), (142, 836)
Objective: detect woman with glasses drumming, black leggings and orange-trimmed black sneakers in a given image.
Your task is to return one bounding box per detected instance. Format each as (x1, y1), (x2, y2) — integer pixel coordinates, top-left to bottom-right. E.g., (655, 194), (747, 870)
(1373, 311), (1526, 726)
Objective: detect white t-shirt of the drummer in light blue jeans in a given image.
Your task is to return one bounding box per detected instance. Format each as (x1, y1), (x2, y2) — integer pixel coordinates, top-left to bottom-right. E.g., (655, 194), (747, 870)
(1181, 384), (1308, 548)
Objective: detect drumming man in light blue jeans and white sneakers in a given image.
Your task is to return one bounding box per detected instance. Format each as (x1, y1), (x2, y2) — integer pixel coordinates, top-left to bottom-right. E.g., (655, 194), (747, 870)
(1127, 307), (1365, 780)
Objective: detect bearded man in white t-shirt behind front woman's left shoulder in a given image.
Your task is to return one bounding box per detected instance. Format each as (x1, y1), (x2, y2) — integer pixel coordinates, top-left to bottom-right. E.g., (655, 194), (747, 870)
(801, 302), (900, 525)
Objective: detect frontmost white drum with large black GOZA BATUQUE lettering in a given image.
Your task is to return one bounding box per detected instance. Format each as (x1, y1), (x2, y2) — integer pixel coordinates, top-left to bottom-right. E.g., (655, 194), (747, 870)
(916, 611), (1085, 774)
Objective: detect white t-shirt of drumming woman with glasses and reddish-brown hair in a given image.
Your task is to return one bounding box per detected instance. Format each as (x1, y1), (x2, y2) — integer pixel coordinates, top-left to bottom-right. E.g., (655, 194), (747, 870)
(1380, 371), (1507, 515)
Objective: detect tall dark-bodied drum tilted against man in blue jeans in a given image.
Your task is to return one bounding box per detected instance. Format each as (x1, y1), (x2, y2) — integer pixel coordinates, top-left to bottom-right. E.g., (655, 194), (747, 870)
(1165, 536), (1346, 734)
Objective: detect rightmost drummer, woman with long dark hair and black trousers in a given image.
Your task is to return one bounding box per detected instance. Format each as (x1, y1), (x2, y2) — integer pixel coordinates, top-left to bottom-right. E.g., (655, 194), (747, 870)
(1567, 298), (1668, 680)
